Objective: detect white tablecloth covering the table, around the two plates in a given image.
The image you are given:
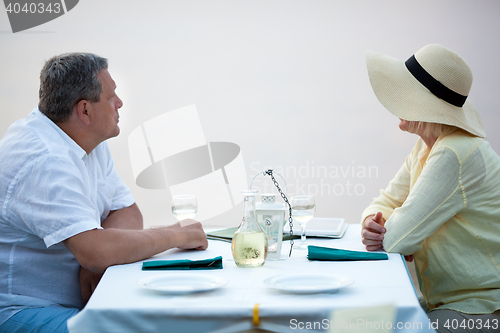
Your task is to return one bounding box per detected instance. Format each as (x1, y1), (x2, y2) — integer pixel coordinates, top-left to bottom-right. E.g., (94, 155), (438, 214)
(68, 225), (433, 333)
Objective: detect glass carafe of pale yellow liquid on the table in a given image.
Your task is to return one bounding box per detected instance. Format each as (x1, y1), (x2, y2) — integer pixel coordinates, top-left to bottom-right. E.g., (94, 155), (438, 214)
(231, 190), (267, 267)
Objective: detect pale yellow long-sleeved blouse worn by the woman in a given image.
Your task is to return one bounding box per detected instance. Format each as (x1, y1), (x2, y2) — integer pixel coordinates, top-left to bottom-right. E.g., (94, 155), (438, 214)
(362, 129), (500, 313)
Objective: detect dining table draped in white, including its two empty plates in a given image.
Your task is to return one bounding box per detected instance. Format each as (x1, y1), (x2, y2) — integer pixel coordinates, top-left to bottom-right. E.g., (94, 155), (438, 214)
(68, 224), (434, 333)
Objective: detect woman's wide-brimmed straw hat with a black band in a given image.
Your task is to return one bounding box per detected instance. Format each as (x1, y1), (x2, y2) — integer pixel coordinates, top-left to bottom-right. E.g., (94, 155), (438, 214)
(365, 44), (486, 137)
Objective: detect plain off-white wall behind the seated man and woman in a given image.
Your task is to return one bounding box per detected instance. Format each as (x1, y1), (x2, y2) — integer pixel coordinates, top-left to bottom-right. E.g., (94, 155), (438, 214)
(0, 0), (500, 226)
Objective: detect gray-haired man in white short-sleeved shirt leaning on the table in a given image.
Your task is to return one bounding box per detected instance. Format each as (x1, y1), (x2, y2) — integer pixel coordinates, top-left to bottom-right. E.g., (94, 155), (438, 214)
(0, 53), (208, 333)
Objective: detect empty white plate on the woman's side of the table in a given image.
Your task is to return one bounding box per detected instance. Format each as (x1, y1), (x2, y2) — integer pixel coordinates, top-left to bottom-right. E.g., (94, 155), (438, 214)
(264, 274), (354, 294)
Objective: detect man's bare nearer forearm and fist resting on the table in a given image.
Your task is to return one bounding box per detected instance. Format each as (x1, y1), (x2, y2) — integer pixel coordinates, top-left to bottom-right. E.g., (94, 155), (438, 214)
(64, 218), (208, 272)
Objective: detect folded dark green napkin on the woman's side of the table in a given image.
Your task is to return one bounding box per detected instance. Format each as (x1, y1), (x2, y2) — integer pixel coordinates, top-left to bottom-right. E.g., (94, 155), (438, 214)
(307, 245), (389, 261)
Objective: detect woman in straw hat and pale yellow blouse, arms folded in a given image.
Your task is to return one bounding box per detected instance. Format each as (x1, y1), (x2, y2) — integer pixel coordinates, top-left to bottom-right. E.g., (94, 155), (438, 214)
(362, 44), (500, 332)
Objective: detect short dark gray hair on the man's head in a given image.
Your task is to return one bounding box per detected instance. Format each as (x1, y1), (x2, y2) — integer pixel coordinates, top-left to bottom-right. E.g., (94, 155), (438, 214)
(38, 53), (108, 123)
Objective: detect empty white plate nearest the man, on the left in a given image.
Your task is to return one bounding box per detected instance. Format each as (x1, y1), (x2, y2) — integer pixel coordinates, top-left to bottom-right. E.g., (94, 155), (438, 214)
(137, 274), (227, 294)
